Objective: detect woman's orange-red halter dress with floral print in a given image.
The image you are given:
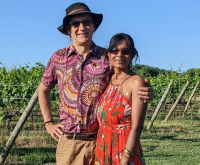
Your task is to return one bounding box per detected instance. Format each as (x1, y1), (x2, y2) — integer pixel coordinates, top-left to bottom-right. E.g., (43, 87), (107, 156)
(95, 79), (145, 165)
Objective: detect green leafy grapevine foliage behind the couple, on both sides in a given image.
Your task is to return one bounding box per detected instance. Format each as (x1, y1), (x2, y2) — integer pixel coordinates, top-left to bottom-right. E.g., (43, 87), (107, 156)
(0, 62), (200, 122)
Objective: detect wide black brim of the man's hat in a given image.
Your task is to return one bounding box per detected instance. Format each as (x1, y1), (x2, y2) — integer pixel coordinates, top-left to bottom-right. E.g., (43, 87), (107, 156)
(57, 11), (103, 34)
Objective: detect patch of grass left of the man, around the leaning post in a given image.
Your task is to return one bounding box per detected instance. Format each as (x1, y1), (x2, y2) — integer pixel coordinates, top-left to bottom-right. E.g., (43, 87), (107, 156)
(0, 130), (57, 165)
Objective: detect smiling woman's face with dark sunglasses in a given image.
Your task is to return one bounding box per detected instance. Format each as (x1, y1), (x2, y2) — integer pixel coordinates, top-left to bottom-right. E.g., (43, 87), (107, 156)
(108, 39), (133, 70)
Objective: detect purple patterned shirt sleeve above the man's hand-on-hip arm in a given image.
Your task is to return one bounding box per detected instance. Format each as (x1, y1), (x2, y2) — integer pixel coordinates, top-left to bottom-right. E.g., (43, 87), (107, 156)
(41, 54), (57, 89)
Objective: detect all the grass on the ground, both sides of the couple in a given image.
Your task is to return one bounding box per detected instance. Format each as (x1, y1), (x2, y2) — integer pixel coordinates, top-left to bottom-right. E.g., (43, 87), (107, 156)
(0, 118), (200, 165)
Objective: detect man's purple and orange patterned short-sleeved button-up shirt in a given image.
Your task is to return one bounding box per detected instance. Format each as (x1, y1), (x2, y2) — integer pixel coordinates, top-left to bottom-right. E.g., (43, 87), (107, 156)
(42, 42), (111, 133)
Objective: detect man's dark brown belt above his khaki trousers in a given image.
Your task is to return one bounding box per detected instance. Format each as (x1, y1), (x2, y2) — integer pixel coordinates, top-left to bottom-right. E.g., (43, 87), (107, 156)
(64, 132), (97, 141)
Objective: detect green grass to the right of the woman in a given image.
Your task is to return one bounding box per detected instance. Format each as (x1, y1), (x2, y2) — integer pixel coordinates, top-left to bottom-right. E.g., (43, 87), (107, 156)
(141, 120), (200, 165)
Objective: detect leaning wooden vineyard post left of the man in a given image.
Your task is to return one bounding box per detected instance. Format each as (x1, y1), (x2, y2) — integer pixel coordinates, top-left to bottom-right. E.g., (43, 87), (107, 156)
(0, 88), (38, 164)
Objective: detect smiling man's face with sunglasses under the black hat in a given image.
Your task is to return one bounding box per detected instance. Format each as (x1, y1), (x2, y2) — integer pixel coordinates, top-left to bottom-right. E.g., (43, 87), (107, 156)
(68, 14), (95, 46)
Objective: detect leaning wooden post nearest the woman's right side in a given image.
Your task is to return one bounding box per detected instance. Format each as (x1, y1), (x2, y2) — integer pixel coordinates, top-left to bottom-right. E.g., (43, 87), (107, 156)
(147, 80), (173, 130)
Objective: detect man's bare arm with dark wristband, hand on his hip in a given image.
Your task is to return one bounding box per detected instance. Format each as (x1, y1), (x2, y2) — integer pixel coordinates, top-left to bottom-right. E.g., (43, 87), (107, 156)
(38, 82), (64, 141)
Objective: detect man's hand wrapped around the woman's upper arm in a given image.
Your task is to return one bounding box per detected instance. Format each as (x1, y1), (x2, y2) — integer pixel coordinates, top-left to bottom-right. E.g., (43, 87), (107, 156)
(137, 79), (155, 103)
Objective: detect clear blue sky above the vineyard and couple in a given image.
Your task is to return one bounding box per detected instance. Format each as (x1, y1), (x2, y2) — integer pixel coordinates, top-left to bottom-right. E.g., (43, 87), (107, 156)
(0, 0), (200, 72)
